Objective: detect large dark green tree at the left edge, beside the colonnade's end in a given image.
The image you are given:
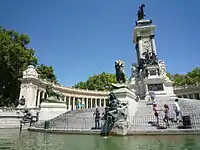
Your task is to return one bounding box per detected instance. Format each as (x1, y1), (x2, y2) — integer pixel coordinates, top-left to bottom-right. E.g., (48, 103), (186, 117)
(0, 27), (37, 106)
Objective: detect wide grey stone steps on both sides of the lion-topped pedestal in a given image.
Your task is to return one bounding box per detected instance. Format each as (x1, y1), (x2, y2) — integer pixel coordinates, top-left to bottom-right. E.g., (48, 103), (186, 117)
(35, 96), (200, 131)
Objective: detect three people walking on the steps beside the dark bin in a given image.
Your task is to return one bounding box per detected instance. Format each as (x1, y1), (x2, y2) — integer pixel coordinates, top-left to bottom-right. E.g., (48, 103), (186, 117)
(153, 99), (182, 128)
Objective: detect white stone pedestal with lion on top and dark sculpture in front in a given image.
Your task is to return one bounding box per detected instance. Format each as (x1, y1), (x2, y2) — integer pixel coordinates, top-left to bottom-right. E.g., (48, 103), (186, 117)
(101, 60), (137, 135)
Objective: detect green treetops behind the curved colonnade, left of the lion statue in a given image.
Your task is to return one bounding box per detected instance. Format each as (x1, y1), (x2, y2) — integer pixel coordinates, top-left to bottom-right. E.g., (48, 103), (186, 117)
(74, 72), (116, 91)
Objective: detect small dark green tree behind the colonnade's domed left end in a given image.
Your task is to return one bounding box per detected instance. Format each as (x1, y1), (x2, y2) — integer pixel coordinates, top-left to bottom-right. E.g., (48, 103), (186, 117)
(36, 64), (58, 83)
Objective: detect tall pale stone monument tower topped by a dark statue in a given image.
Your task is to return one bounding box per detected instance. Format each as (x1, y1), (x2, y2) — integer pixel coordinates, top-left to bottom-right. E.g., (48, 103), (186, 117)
(129, 4), (175, 99)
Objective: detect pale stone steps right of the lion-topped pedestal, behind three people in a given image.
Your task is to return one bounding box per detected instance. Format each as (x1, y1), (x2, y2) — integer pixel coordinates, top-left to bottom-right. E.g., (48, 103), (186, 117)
(131, 96), (200, 130)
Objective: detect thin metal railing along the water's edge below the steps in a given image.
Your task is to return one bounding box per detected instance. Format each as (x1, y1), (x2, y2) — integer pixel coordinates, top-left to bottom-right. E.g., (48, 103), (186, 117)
(34, 114), (200, 130)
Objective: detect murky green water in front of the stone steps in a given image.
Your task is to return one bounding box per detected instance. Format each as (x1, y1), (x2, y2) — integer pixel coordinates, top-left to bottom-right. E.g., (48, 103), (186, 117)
(0, 130), (200, 150)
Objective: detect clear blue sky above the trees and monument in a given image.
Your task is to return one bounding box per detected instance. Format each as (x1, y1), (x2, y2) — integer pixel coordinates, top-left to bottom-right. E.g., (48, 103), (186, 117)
(0, 0), (200, 86)
